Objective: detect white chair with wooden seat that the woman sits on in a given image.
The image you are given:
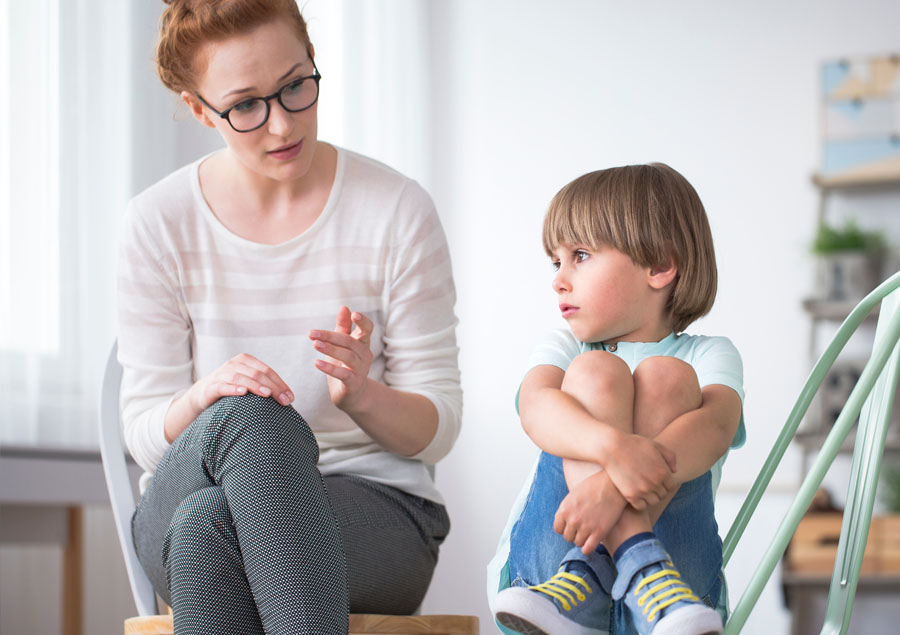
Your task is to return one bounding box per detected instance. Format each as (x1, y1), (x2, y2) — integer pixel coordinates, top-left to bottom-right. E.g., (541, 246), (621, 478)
(100, 342), (479, 635)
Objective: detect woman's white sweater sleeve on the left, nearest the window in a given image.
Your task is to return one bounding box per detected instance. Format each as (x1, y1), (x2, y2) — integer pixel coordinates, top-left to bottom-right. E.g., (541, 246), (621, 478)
(117, 201), (193, 472)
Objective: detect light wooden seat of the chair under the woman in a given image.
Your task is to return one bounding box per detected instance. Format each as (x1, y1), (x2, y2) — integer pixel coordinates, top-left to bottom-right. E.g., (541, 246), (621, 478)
(125, 613), (479, 635)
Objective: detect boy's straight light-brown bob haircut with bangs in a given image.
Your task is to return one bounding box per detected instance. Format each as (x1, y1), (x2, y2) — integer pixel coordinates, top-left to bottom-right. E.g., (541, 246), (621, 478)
(543, 163), (717, 333)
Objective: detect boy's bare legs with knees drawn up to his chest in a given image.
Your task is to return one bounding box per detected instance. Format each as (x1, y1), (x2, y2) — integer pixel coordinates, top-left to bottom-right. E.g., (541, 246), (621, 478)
(562, 351), (702, 553)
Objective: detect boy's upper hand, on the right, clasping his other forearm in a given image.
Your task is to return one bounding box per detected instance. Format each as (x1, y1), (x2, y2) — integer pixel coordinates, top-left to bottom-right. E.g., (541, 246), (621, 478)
(603, 434), (677, 510)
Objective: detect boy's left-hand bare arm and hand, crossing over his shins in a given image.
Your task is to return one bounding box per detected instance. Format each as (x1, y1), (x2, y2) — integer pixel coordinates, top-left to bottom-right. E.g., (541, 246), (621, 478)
(519, 365), (676, 509)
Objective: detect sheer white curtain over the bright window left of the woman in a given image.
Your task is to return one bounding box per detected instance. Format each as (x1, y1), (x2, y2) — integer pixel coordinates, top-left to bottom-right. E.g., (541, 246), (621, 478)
(0, 0), (130, 445)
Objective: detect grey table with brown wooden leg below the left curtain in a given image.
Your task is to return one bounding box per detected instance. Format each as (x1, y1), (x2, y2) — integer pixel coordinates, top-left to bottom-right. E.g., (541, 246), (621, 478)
(0, 445), (142, 635)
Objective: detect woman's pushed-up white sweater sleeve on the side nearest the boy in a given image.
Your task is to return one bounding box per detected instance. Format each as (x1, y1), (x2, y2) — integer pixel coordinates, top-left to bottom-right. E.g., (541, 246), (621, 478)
(384, 182), (462, 463)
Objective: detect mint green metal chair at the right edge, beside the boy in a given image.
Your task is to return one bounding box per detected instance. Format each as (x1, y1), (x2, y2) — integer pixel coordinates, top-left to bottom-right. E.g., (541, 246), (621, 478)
(723, 272), (900, 635)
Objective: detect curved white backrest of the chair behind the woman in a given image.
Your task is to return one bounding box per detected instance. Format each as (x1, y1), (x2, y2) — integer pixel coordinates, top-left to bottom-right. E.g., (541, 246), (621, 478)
(100, 342), (157, 615)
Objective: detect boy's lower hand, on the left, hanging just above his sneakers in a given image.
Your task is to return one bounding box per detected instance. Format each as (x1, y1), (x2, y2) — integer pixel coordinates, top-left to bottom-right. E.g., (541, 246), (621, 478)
(553, 470), (628, 555)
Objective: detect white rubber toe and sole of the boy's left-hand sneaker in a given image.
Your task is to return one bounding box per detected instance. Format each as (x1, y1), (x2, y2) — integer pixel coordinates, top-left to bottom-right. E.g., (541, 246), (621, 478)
(494, 587), (612, 635)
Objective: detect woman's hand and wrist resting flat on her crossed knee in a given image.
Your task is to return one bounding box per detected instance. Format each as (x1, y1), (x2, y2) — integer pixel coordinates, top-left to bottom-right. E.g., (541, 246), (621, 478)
(165, 353), (294, 443)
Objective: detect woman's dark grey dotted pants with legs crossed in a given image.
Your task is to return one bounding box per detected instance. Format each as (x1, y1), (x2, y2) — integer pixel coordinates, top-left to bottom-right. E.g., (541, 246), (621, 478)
(132, 395), (449, 635)
